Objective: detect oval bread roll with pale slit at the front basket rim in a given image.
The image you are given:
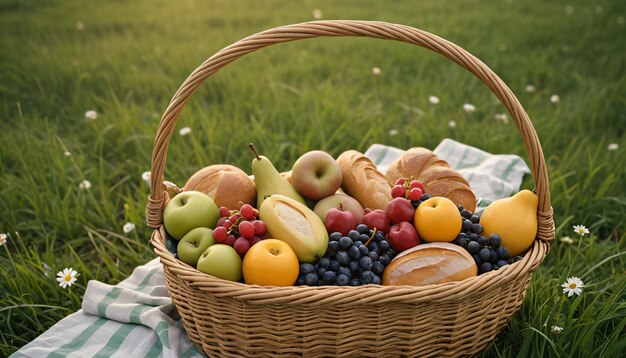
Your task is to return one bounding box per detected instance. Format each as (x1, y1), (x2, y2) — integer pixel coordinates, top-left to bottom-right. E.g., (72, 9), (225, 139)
(383, 242), (478, 286)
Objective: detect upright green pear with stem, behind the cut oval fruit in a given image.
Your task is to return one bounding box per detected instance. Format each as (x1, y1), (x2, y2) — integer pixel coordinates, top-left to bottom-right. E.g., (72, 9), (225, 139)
(250, 143), (306, 208)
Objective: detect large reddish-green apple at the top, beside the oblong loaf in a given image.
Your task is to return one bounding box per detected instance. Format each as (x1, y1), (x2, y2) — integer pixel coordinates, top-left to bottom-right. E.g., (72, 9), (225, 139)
(291, 150), (342, 200)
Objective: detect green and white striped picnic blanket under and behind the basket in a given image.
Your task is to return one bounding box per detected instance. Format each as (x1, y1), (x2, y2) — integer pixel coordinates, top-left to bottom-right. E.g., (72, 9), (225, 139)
(11, 139), (530, 358)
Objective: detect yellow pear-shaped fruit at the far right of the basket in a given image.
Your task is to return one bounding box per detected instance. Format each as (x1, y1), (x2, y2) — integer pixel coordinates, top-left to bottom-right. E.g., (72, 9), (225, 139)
(480, 190), (538, 257)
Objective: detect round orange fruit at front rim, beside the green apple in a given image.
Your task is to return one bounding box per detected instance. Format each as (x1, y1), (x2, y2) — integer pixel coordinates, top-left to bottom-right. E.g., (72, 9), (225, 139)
(242, 239), (300, 286)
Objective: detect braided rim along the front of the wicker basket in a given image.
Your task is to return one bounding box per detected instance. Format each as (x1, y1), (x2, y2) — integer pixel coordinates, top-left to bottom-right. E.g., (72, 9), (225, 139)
(150, 226), (549, 305)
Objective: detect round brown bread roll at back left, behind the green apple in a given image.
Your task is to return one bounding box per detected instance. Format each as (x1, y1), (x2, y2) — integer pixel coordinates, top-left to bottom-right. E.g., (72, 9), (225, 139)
(185, 164), (256, 210)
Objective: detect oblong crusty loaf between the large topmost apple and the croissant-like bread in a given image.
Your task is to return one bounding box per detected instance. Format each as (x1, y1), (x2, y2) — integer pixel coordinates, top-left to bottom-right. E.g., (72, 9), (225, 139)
(337, 150), (391, 210)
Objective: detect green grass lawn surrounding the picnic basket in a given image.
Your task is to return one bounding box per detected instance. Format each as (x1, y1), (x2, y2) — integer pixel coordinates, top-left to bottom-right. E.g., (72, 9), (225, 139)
(0, 0), (626, 357)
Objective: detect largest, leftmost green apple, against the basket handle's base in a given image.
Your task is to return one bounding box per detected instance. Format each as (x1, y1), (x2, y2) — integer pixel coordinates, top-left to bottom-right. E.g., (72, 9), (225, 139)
(163, 191), (220, 240)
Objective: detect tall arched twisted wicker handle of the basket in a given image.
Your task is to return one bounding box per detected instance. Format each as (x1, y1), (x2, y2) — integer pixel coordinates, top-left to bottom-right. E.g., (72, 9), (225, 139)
(146, 20), (554, 242)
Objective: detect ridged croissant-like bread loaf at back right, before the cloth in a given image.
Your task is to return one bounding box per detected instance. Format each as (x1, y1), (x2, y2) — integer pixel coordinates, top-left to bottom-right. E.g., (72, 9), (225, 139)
(386, 147), (476, 212)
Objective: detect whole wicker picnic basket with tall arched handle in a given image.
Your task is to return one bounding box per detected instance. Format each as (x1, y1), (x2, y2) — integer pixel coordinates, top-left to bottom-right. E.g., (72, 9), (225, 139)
(146, 21), (554, 357)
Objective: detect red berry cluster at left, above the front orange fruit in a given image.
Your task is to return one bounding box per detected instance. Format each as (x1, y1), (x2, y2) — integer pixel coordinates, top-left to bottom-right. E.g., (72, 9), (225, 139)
(213, 204), (269, 257)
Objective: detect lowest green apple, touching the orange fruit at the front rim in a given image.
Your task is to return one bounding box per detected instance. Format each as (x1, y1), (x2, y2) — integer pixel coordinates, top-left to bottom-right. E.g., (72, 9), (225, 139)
(196, 244), (241, 281)
